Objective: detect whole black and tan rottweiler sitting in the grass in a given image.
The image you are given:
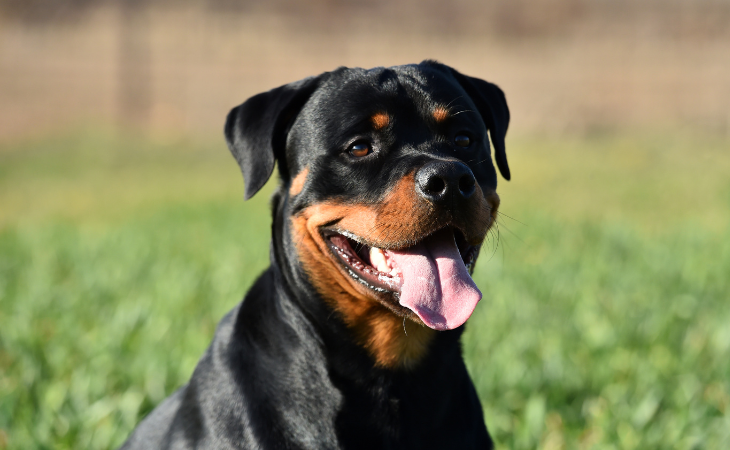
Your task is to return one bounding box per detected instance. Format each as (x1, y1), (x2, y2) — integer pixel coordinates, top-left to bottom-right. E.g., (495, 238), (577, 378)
(122, 61), (510, 450)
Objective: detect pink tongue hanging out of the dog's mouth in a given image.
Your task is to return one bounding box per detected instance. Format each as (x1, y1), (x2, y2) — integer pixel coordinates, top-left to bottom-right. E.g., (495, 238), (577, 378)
(388, 229), (482, 330)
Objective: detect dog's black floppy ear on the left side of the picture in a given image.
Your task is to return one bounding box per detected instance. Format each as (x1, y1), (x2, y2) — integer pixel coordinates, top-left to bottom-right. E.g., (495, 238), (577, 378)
(225, 75), (324, 200)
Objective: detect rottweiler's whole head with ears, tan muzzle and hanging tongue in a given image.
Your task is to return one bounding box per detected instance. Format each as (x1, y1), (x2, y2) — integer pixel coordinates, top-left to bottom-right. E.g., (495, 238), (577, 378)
(226, 62), (509, 365)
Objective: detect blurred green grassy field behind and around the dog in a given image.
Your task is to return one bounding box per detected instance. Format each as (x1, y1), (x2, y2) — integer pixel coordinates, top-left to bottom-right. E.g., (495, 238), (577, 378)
(0, 130), (730, 449)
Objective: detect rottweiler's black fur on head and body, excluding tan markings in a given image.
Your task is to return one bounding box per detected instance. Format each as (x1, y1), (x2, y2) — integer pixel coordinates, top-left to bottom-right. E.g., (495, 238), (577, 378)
(122, 61), (510, 450)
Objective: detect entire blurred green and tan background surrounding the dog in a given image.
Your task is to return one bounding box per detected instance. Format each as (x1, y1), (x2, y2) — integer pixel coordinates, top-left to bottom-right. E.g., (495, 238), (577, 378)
(0, 0), (730, 449)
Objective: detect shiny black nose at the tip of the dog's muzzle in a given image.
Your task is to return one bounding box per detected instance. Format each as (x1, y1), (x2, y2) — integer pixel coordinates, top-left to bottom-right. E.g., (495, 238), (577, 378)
(416, 161), (476, 204)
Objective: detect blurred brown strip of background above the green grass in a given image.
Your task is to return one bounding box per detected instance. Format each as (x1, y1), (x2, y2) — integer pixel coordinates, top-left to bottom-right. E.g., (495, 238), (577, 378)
(0, 0), (730, 137)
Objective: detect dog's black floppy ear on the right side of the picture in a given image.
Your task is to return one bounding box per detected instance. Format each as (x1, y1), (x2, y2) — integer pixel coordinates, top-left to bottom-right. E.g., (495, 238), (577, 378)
(450, 68), (510, 180)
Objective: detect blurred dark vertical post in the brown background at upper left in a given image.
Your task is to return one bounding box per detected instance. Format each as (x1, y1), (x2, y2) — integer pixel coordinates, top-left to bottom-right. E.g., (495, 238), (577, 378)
(117, 0), (153, 129)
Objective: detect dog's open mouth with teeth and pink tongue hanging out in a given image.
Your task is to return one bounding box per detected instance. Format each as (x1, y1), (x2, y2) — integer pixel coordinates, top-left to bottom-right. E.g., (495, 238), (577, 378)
(323, 227), (481, 330)
